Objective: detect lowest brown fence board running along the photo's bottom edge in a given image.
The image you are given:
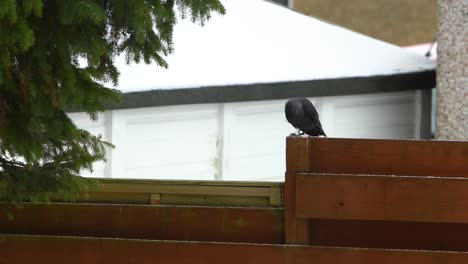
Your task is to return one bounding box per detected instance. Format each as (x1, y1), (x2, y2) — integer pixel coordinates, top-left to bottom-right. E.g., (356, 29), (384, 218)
(0, 235), (468, 264)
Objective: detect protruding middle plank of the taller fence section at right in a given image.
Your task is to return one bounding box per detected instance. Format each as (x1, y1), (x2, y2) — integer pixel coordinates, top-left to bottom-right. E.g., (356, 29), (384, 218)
(296, 174), (468, 223)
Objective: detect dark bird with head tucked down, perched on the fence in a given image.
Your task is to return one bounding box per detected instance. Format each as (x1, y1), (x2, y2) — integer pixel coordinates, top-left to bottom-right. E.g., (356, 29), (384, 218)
(284, 97), (327, 137)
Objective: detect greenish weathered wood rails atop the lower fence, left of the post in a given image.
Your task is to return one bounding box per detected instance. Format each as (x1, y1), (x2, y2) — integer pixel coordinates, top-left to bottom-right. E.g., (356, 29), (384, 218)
(70, 179), (284, 207)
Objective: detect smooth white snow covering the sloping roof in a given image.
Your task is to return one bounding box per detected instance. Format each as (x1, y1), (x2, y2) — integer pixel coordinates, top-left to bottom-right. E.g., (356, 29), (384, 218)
(109, 0), (434, 93)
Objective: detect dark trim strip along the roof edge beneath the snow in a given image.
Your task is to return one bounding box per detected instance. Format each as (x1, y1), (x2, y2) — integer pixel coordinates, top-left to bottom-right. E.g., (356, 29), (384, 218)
(102, 70), (436, 109)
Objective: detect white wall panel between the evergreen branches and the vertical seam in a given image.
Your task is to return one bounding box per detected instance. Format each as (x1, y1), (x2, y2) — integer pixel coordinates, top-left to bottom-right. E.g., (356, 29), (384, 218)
(112, 105), (217, 180)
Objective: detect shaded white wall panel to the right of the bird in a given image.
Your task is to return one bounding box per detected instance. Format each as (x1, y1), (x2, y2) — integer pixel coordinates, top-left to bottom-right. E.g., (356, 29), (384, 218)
(320, 92), (416, 139)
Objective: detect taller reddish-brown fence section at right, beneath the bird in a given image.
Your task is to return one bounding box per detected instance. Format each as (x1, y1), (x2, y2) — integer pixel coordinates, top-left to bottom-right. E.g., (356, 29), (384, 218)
(285, 138), (468, 250)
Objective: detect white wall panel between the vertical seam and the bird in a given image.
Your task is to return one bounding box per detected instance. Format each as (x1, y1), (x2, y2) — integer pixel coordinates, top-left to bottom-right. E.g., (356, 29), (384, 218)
(223, 100), (292, 180)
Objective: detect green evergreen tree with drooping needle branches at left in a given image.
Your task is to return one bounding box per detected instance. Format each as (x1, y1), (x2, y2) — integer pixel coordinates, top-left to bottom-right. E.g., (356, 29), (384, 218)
(0, 0), (225, 202)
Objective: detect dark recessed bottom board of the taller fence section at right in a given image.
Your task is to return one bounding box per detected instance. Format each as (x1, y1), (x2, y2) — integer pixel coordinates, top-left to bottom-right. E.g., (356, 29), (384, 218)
(309, 219), (468, 251)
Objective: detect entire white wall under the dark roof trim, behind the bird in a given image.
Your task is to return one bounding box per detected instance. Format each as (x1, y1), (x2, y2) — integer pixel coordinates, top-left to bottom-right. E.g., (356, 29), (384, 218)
(70, 91), (428, 180)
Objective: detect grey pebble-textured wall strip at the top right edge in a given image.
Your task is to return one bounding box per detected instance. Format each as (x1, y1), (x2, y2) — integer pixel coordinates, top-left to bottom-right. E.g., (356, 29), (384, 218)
(436, 0), (468, 140)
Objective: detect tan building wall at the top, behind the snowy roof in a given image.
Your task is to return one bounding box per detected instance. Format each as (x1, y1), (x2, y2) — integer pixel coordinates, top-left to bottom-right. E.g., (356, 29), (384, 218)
(290, 0), (437, 46)
